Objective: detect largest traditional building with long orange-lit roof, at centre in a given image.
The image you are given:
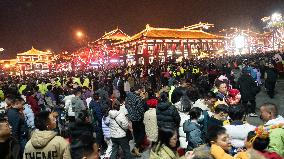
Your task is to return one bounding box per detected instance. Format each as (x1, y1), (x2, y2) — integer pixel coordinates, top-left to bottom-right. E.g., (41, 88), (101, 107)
(115, 25), (224, 64)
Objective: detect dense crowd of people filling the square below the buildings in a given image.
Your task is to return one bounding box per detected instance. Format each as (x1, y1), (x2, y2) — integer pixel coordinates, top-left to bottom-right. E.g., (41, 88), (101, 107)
(0, 53), (284, 159)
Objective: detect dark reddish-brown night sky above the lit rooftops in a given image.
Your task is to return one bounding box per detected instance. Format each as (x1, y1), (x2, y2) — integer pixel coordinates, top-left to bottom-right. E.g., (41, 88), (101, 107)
(0, 0), (284, 58)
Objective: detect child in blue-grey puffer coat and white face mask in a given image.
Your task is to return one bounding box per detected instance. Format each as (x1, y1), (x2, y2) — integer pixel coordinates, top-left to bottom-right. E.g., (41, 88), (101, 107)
(183, 107), (204, 151)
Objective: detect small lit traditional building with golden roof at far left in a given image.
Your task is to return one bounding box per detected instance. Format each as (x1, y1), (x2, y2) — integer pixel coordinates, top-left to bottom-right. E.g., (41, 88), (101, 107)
(16, 47), (54, 74)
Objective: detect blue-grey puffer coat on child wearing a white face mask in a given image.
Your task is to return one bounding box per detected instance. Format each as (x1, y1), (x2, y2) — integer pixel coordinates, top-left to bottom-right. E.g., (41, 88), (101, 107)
(183, 120), (204, 151)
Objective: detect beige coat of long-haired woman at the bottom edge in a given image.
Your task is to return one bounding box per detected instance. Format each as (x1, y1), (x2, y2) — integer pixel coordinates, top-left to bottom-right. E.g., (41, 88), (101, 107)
(150, 144), (184, 159)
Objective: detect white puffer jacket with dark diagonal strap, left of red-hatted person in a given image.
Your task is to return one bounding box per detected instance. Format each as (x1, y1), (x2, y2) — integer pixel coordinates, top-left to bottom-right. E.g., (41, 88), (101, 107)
(109, 110), (128, 138)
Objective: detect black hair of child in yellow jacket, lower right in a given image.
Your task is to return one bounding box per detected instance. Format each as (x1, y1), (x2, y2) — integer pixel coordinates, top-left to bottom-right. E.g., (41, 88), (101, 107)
(207, 125), (226, 145)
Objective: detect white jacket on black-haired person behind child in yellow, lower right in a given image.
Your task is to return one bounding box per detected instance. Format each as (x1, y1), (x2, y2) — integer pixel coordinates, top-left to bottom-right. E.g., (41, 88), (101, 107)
(224, 123), (255, 148)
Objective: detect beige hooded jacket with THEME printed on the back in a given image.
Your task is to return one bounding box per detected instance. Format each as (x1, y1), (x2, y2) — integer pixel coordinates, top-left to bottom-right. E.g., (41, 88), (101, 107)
(23, 130), (71, 159)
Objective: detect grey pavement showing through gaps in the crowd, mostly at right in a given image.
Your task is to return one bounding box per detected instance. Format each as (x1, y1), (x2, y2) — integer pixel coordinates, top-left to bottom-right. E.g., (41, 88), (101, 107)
(135, 80), (284, 159)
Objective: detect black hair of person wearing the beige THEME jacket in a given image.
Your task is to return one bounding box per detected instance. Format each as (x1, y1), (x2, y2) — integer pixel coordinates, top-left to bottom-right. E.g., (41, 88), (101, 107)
(35, 111), (50, 131)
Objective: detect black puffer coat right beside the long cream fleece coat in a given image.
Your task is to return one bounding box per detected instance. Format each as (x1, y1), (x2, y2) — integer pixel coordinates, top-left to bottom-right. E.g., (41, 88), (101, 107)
(156, 102), (180, 128)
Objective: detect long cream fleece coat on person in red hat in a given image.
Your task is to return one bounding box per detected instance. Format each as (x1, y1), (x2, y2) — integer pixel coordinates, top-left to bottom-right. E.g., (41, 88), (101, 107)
(143, 108), (158, 142)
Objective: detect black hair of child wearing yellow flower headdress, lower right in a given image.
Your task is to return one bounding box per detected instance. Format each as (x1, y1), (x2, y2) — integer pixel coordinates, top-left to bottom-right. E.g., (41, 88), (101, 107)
(247, 131), (270, 151)
